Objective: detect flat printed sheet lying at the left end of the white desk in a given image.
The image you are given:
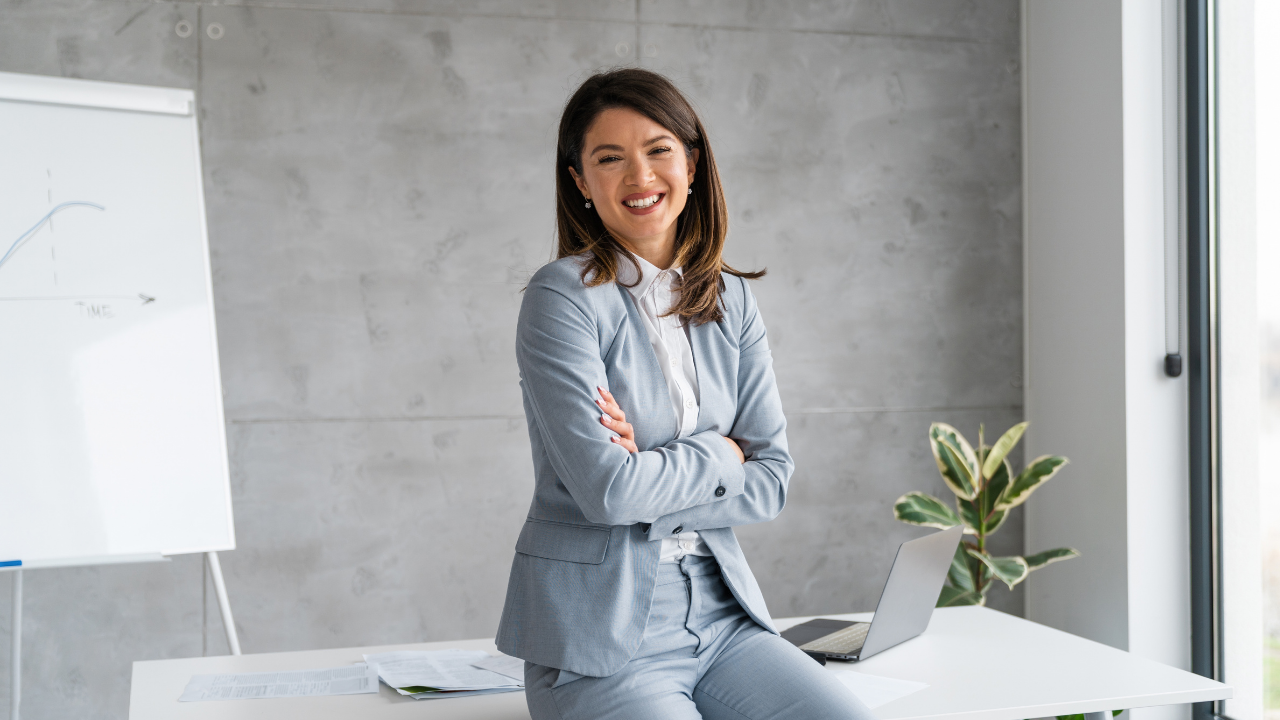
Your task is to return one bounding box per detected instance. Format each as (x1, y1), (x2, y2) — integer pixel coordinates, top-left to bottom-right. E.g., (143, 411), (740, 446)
(178, 662), (378, 702)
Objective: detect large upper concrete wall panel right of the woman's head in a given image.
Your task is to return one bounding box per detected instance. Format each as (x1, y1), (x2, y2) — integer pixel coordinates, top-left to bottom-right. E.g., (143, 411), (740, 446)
(643, 26), (1021, 409)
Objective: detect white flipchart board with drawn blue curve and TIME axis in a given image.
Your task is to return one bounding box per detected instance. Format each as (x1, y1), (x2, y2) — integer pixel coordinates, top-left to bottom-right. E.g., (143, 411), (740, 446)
(0, 73), (236, 568)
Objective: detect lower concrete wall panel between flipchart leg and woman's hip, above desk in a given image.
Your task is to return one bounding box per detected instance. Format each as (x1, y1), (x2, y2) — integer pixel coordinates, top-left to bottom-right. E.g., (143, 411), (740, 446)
(223, 418), (534, 652)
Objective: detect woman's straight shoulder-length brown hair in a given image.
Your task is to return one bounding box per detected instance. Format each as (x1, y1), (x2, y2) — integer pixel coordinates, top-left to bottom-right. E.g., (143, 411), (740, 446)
(556, 68), (764, 325)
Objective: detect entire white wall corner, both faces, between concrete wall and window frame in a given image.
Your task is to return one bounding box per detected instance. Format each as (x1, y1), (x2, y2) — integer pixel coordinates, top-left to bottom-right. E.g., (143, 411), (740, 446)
(1023, 0), (1190, 719)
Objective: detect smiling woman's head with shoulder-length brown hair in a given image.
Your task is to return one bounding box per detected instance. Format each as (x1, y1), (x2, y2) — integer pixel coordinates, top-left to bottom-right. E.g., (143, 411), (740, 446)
(556, 69), (764, 323)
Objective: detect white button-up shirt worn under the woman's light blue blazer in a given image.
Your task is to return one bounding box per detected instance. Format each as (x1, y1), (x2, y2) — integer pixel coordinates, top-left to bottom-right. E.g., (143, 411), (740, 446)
(618, 251), (712, 562)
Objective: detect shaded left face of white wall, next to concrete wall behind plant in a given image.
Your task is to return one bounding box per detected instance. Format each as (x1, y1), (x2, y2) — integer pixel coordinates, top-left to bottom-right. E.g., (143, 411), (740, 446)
(1023, 0), (1129, 648)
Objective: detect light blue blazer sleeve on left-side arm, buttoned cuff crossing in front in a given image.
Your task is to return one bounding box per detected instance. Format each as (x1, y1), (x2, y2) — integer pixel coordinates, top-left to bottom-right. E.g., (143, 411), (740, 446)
(516, 274), (746, 525)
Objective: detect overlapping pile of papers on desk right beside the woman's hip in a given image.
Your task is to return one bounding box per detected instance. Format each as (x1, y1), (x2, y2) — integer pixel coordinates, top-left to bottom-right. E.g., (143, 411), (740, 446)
(365, 650), (525, 700)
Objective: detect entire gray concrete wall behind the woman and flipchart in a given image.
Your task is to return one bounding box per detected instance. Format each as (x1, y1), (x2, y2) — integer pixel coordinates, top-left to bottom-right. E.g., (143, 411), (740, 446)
(0, 0), (1018, 719)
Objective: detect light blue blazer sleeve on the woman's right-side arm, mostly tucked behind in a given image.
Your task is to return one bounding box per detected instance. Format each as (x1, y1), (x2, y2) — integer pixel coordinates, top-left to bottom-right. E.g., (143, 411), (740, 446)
(649, 278), (795, 541)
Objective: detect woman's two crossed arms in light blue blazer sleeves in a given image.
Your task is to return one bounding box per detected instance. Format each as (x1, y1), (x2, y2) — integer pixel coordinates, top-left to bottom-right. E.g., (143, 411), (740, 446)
(516, 278), (794, 539)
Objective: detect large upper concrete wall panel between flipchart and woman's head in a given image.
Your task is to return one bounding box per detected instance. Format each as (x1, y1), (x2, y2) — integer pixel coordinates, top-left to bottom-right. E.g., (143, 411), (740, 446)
(201, 8), (634, 419)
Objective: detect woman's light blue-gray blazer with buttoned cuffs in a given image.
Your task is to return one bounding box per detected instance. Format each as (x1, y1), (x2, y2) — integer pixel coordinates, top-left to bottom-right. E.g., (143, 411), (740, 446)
(498, 258), (794, 678)
